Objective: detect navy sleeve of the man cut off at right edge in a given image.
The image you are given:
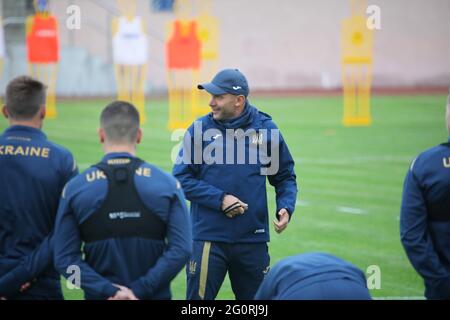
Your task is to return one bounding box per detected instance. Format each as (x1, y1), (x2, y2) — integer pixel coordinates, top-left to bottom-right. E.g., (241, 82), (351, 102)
(400, 160), (448, 280)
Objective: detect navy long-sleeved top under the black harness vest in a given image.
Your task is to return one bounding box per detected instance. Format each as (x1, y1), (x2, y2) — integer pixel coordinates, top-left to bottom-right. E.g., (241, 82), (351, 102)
(54, 153), (192, 299)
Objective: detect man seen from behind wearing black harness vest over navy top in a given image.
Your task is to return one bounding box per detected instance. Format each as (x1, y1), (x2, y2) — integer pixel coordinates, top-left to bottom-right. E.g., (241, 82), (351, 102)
(54, 101), (192, 300)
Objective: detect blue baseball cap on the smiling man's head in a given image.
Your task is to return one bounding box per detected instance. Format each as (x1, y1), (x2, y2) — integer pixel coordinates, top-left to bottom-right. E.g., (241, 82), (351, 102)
(197, 69), (249, 97)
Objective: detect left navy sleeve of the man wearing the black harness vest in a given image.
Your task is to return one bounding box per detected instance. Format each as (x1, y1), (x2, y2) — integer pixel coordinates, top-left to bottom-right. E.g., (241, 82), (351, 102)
(53, 184), (118, 299)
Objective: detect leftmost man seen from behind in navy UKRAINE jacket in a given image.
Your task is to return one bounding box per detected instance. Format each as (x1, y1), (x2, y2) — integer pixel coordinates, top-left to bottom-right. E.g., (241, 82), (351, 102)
(0, 77), (78, 299)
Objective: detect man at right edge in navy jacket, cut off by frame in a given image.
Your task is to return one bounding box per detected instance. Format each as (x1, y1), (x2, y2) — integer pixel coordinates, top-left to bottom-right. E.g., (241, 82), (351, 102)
(400, 96), (450, 299)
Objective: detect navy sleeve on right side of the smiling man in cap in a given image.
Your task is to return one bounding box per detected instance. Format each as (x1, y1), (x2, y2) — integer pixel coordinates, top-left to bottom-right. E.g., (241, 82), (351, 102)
(267, 123), (298, 216)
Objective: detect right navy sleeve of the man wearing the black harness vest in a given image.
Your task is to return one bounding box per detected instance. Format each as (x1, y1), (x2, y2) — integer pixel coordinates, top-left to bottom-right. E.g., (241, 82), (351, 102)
(130, 182), (192, 299)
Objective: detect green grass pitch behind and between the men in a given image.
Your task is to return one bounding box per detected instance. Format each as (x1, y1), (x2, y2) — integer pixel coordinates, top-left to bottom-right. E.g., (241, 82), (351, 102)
(0, 96), (448, 299)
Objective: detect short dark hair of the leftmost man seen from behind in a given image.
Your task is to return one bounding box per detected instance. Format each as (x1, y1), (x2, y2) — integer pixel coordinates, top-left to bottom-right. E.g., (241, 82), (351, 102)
(5, 76), (47, 120)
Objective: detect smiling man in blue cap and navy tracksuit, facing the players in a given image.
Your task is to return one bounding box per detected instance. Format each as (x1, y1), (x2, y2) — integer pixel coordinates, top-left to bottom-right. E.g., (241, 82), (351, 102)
(173, 69), (297, 299)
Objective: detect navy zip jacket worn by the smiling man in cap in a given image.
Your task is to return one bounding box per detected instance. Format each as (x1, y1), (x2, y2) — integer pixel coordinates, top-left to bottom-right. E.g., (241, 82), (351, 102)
(173, 102), (297, 243)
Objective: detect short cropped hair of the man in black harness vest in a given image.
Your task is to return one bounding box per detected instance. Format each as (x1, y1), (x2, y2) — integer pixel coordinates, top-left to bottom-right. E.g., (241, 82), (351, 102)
(100, 101), (139, 143)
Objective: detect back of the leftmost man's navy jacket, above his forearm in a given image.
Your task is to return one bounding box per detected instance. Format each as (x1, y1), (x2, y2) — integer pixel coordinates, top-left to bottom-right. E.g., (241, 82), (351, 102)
(0, 125), (77, 271)
